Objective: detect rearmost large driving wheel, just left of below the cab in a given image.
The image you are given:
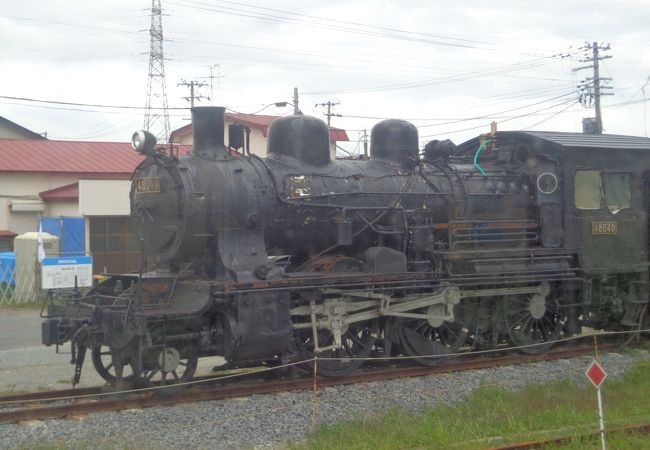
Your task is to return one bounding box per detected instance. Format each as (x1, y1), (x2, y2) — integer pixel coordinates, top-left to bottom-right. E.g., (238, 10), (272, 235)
(503, 286), (568, 355)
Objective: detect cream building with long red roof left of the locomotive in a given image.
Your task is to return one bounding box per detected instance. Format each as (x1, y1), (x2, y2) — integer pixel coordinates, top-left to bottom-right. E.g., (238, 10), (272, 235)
(0, 138), (189, 272)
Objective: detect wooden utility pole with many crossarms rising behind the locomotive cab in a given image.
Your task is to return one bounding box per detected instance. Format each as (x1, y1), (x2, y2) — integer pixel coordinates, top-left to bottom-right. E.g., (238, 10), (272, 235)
(573, 42), (614, 134)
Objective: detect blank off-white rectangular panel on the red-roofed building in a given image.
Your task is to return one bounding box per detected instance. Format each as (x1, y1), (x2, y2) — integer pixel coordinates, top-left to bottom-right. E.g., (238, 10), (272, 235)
(79, 180), (131, 216)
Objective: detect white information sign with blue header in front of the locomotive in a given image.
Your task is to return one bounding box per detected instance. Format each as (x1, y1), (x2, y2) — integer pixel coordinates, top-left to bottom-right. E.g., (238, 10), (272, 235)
(41, 256), (93, 289)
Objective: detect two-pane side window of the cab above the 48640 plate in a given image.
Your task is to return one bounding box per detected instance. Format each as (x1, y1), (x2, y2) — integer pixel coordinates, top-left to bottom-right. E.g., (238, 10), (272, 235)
(574, 170), (631, 213)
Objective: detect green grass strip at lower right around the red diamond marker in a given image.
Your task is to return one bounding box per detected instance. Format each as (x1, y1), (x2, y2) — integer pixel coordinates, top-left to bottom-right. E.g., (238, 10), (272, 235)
(288, 362), (650, 449)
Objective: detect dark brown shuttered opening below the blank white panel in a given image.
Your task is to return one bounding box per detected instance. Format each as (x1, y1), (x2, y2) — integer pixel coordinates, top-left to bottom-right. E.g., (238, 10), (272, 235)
(89, 217), (140, 273)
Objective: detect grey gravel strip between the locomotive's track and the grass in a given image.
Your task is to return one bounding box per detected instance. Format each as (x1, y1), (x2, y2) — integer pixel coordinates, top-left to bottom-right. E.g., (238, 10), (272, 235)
(0, 351), (650, 449)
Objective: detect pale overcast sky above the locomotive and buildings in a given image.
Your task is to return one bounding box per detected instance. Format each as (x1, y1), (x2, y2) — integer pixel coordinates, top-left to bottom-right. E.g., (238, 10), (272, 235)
(0, 0), (650, 151)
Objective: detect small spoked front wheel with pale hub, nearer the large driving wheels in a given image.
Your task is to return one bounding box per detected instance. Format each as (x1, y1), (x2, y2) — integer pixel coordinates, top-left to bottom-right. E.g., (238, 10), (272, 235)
(131, 327), (199, 387)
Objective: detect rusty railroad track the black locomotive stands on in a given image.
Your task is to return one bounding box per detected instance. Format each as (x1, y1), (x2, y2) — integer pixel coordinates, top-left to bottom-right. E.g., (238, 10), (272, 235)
(0, 344), (620, 423)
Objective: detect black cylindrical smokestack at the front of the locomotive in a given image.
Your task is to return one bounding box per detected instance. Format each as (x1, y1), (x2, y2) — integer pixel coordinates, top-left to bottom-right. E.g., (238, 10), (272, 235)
(192, 106), (229, 159)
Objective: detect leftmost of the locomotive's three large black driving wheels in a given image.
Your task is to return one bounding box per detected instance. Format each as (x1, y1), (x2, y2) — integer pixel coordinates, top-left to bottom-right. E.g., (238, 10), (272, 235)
(296, 320), (379, 377)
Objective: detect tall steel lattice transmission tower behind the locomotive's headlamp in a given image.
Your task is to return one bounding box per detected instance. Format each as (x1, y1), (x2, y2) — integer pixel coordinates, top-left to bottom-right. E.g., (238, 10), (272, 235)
(144, 0), (169, 143)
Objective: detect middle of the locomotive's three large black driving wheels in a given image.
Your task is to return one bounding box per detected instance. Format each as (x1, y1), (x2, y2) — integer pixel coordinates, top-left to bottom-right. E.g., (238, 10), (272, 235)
(393, 305), (468, 366)
